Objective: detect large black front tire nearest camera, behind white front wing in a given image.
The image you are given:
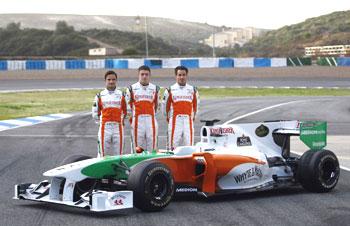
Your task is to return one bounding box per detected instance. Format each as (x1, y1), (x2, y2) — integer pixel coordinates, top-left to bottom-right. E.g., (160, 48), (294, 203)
(127, 161), (175, 212)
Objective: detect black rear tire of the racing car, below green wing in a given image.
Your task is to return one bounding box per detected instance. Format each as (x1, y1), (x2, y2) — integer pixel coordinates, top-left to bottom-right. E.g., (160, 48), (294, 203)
(297, 150), (340, 193)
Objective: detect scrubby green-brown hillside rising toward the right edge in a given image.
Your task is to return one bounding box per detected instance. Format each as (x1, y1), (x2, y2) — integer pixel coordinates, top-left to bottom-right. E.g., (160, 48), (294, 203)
(239, 10), (350, 57)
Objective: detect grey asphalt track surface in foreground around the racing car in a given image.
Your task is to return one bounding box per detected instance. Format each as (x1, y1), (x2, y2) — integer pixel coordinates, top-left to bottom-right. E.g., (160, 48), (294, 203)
(0, 66), (350, 226)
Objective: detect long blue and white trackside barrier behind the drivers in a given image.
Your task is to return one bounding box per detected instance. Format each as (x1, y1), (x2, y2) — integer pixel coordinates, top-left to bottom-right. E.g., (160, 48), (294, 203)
(0, 57), (350, 71)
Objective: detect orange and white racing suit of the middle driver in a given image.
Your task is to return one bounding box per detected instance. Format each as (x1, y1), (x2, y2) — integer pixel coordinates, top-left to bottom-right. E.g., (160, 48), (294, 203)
(126, 82), (159, 151)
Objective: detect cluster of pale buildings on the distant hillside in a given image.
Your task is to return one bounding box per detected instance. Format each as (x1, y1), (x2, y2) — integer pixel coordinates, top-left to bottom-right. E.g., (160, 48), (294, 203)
(204, 27), (262, 48)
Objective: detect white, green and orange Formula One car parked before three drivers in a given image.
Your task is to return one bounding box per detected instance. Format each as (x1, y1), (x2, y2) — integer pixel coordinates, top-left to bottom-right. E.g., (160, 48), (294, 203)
(14, 120), (340, 211)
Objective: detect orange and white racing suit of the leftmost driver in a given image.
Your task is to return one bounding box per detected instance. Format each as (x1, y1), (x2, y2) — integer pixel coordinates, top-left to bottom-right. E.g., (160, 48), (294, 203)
(92, 89), (126, 157)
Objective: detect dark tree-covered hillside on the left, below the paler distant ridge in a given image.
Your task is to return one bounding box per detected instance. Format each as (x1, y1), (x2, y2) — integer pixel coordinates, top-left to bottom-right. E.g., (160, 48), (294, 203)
(0, 21), (211, 57)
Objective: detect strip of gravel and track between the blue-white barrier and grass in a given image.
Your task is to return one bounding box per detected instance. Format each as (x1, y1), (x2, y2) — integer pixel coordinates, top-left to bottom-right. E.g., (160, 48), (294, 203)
(0, 66), (350, 91)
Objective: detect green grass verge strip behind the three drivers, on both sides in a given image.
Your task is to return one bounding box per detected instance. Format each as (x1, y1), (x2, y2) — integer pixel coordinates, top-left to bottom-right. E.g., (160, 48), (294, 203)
(0, 88), (350, 120)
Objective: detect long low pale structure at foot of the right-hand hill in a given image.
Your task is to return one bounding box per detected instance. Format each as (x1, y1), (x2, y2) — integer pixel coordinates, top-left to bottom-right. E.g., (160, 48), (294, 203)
(305, 45), (350, 56)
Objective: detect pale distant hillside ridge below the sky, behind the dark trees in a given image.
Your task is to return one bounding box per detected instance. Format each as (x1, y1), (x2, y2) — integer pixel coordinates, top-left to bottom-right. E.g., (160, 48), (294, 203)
(0, 14), (221, 43)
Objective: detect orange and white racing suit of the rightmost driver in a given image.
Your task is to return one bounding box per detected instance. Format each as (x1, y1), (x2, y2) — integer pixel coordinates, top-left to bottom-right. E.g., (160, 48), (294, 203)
(163, 83), (199, 150)
